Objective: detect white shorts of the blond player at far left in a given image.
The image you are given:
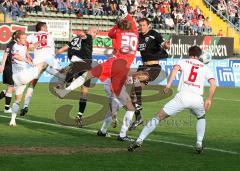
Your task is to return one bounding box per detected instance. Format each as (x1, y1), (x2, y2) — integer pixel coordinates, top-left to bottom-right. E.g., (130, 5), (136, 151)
(13, 66), (39, 95)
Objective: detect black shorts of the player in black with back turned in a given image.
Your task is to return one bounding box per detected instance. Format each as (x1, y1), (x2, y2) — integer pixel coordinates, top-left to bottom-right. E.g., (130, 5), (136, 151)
(65, 62), (91, 87)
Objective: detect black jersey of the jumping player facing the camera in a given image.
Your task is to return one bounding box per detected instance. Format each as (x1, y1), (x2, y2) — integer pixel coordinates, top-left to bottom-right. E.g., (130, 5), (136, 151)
(138, 30), (168, 62)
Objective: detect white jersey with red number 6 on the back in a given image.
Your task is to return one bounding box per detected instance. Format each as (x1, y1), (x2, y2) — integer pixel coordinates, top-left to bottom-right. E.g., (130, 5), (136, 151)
(177, 59), (214, 95)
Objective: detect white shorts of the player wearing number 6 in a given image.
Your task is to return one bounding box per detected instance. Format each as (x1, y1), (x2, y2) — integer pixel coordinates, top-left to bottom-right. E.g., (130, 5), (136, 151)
(163, 92), (205, 118)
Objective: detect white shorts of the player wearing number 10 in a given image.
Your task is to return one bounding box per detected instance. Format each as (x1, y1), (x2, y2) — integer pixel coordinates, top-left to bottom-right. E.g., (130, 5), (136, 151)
(33, 56), (62, 69)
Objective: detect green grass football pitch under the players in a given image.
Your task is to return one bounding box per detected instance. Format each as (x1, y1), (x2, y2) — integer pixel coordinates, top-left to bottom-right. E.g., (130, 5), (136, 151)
(0, 84), (240, 171)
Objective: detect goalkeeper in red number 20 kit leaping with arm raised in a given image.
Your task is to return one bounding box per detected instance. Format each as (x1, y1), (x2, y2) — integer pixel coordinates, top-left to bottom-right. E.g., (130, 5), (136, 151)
(55, 5), (138, 141)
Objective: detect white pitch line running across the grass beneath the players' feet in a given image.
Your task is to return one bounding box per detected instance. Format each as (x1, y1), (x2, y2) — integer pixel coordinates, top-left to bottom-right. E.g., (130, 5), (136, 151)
(0, 115), (240, 155)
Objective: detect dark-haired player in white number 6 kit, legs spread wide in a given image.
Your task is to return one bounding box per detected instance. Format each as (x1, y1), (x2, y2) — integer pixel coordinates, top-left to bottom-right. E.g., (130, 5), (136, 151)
(128, 46), (216, 153)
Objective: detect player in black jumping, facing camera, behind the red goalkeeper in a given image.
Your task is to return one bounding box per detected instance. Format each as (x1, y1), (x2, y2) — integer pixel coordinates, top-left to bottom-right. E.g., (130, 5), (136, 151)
(130, 18), (170, 130)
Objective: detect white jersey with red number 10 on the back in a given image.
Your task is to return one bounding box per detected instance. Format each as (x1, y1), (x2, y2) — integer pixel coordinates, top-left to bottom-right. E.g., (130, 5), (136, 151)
(27, 31), (55, 58)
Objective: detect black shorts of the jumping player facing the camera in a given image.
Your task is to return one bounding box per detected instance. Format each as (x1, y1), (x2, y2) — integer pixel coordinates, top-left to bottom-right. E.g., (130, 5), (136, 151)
(137, 64), (162, 84)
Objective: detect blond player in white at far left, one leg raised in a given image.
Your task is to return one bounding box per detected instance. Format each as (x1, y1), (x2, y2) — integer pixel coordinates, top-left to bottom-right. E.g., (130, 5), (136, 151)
(9, 31), (64, 126)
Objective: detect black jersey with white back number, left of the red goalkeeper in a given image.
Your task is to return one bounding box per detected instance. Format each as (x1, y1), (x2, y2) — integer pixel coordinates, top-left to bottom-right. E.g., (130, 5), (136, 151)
(68, 34), (93, 62)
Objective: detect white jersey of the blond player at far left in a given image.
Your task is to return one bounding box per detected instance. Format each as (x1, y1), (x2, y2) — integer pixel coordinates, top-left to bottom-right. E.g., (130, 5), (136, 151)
(11, 43), (28, 73)
